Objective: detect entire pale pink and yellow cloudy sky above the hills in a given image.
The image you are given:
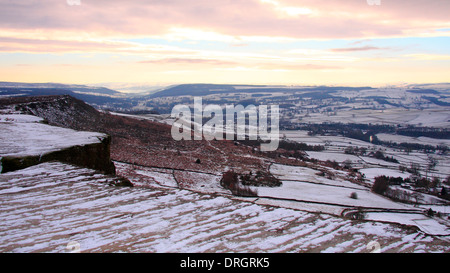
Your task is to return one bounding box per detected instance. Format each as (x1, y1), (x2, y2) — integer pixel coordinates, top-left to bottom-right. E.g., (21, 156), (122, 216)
(0, 0), (450, 86)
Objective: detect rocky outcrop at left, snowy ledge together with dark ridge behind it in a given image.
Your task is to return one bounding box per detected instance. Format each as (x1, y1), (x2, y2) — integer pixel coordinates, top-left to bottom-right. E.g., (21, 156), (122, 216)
(0, 96), (115, 174)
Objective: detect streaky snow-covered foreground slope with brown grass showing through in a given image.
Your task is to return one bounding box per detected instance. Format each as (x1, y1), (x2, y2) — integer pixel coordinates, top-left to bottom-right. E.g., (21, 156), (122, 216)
(0, 162), (450, 252)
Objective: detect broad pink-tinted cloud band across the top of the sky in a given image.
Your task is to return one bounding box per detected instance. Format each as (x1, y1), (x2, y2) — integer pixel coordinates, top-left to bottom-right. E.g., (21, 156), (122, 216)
(0, 0), (450, 39)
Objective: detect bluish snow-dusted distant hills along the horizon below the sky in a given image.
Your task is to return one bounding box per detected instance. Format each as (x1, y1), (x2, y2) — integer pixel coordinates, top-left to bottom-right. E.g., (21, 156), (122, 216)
(0, 82), (450, 114)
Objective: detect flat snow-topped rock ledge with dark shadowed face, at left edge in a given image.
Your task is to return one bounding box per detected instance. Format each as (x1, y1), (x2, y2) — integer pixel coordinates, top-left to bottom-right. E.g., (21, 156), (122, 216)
(0, 115), (115, 174)
